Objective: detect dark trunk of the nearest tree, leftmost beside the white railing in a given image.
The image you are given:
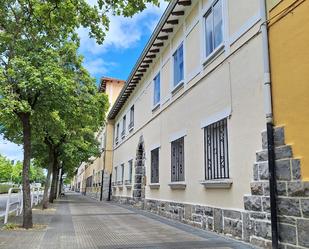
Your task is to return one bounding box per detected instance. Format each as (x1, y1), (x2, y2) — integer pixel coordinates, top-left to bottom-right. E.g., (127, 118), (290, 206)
(19, 113), (33, 229)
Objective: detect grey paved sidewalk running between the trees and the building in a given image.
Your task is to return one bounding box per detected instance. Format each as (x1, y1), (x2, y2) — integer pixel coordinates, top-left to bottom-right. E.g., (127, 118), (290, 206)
(0, 193), (253, 249)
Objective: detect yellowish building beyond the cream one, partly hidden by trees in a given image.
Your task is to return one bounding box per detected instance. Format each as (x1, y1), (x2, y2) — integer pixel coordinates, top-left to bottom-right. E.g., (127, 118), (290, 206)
(75, 77), (124, 200)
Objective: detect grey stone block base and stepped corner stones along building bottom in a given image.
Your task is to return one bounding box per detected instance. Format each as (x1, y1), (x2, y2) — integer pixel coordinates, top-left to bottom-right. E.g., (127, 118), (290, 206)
(114, 127), (309, 249)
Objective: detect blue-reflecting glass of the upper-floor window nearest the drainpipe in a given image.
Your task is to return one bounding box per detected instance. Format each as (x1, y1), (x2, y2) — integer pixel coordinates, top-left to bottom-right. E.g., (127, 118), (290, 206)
(205, 0), (223, 57)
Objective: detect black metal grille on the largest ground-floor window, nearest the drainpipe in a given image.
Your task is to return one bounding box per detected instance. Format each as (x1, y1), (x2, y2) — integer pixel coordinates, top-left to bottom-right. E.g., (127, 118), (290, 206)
(204, 118), (229, 180)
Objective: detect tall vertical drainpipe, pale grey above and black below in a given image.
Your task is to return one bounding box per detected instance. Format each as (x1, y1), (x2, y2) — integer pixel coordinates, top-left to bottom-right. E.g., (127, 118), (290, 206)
(260, 0), (279, 249)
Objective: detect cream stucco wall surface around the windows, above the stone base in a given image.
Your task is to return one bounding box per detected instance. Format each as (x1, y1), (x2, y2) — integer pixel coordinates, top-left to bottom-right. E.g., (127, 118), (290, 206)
(113, 0), (265, 208)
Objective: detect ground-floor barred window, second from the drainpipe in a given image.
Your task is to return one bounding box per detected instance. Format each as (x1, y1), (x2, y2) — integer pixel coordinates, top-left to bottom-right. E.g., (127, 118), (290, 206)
(171, 137), (185, 182)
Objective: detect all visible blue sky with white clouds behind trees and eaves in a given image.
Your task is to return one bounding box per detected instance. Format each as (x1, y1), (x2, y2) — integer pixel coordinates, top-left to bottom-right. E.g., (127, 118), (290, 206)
(0, 0), (167, 160)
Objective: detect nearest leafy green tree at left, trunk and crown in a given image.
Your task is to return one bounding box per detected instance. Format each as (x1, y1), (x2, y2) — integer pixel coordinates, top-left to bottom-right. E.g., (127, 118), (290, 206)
(0, 0), (158, 228)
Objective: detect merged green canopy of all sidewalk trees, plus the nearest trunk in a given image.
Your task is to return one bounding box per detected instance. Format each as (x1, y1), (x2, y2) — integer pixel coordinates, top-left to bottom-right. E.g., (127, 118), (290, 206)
(0, 0), (159, 228)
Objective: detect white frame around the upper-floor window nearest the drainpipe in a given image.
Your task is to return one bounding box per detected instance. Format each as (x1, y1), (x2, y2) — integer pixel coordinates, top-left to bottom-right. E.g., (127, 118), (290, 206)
(202, 0), (226, 65)
